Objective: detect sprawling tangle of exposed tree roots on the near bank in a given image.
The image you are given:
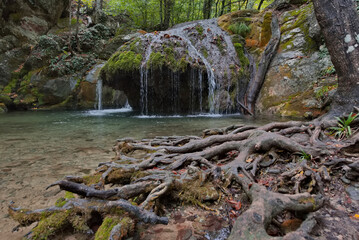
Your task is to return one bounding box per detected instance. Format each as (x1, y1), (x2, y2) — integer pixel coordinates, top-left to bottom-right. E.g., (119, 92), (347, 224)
(9, 113), (359, 239)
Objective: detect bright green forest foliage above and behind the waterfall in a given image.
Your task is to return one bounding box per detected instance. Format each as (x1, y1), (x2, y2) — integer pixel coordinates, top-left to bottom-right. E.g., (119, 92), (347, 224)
(82, 0), (273, 30)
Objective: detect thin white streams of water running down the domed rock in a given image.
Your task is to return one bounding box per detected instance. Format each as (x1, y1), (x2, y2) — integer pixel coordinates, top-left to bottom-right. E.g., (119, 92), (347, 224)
(136, 19), (238, 115)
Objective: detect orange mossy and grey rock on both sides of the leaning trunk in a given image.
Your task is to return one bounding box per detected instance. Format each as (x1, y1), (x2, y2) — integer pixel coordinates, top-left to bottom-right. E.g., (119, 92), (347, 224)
(219, 1), (336, 117)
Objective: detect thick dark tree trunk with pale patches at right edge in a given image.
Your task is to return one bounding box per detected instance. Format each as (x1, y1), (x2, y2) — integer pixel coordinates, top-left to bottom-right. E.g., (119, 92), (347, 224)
(313, 0), (359, 115)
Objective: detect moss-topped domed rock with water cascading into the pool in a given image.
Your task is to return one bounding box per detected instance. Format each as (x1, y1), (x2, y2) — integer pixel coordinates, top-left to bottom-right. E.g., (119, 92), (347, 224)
(114, 19), (241, 115)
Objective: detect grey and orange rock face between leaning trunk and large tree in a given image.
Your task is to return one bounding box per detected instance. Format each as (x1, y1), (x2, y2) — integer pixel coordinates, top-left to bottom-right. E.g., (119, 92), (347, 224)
(257, 4), (331, 118)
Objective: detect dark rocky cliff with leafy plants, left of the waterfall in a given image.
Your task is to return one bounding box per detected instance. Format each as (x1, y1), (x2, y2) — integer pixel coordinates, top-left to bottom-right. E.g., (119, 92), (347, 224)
(0, 0), (134, 112)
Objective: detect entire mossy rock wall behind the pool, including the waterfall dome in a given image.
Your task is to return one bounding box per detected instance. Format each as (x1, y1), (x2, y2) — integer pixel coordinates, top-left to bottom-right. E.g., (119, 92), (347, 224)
(0, 0), (336, 116)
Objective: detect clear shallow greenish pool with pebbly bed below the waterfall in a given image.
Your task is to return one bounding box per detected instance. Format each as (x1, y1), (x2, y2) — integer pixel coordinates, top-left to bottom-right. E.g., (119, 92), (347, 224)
(0, 109), (276, 239)
